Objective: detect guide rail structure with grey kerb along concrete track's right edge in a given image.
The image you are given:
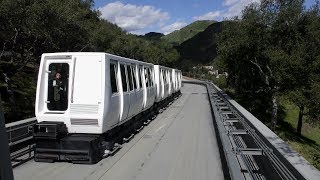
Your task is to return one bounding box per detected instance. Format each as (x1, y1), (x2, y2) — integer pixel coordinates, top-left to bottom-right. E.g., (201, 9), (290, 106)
(183, 81), (305, 180)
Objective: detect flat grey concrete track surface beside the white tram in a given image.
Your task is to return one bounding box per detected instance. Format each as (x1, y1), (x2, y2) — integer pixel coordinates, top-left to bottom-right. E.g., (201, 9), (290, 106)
(14, 84), (223, 180)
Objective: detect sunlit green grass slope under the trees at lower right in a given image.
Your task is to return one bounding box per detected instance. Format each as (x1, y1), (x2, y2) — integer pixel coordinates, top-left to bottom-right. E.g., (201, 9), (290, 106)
(277, 100), (320, 170)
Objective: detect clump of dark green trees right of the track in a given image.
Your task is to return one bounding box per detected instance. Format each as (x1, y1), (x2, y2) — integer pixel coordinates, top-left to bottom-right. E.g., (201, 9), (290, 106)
(218, 0), (320, 133)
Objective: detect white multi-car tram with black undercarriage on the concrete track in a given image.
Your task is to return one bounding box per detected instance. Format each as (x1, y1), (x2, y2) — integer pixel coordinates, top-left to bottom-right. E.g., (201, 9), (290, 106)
(34, 52), (182, 163)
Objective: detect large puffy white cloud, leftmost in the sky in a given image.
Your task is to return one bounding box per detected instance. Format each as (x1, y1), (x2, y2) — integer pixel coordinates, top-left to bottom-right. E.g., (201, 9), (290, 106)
(99, 1), (169, 33)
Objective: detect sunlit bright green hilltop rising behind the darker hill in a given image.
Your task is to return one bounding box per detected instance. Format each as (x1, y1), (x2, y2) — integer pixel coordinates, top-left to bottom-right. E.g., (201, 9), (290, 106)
(162, 20), (215, 45)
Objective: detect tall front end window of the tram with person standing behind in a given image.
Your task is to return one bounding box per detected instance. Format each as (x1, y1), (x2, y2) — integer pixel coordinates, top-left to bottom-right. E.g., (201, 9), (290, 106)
(47, 63), (69, 111)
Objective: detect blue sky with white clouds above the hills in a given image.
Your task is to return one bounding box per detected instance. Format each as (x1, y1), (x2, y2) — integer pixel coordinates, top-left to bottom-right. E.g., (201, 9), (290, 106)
(95, 0), (315, 34)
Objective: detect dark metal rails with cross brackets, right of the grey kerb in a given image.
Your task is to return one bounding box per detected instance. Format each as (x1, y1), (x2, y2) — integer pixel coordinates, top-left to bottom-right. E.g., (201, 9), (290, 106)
(209, 81), (304, 180)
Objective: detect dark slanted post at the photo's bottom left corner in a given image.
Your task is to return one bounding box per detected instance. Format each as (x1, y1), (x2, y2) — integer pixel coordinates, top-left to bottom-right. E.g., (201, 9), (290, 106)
(0, 94), (13, 180)
